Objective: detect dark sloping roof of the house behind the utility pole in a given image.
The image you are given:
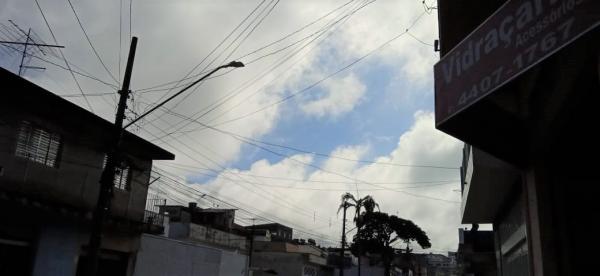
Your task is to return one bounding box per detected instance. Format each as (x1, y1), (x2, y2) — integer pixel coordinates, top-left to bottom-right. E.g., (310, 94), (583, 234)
(0, 68), (175, 160)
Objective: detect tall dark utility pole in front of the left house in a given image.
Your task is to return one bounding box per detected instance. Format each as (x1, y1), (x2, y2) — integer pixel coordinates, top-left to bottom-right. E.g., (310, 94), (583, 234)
(88, 37), (137, 276)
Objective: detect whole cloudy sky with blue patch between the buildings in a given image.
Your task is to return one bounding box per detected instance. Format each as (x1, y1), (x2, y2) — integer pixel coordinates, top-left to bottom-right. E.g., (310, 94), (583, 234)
(0, 0), (462, 252)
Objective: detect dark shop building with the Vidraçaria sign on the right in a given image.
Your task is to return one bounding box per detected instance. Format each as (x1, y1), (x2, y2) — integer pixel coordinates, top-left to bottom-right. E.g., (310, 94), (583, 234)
(434, 0), (600, 276)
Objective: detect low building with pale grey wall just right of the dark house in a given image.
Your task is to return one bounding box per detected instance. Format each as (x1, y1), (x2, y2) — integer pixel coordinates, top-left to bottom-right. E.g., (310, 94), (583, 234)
(134, 202), (248, 276)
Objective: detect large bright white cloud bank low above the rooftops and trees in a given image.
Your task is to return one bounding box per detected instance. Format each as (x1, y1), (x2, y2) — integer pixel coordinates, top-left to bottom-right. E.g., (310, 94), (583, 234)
(183, 111), (462, 250)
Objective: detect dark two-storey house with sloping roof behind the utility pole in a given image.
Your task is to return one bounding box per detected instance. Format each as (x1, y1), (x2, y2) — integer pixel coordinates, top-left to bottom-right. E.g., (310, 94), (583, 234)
(0, 68), (174, 276)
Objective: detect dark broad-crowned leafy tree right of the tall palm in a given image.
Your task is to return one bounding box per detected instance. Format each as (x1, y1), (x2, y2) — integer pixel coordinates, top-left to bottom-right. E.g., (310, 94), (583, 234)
(350, 212), (431, 276)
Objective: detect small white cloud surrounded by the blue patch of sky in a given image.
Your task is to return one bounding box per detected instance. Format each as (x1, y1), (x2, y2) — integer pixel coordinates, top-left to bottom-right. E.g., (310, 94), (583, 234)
(300, 74), (366, 118)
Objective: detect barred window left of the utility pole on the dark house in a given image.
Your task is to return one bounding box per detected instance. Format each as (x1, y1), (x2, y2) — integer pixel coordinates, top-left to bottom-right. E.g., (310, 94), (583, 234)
(15, 121), (60, 167)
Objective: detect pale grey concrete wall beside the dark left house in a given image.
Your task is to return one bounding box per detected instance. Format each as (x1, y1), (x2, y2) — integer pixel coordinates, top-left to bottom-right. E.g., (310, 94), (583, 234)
(134, 235), (247, 276)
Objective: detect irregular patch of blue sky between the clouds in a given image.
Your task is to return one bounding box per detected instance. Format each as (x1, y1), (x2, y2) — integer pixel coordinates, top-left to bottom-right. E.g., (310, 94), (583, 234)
(230, 58), (433, 169)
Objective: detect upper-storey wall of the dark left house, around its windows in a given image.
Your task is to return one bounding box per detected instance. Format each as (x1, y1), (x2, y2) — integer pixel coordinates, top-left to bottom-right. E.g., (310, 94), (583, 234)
(0, 114), (152, 221)
